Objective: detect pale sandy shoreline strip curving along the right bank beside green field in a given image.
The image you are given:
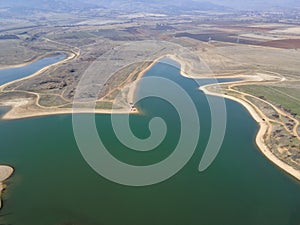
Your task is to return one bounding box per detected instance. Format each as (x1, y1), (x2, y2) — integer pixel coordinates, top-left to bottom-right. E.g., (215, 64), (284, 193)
(199, 82), (300, 181)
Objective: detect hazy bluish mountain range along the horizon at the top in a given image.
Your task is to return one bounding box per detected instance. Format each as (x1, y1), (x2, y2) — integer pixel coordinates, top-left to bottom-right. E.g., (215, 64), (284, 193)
(0, 0), (300, 12)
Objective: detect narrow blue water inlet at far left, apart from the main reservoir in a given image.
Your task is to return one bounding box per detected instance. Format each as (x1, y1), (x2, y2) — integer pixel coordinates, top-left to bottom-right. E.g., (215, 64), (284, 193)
(0, 54), (66, 85)
